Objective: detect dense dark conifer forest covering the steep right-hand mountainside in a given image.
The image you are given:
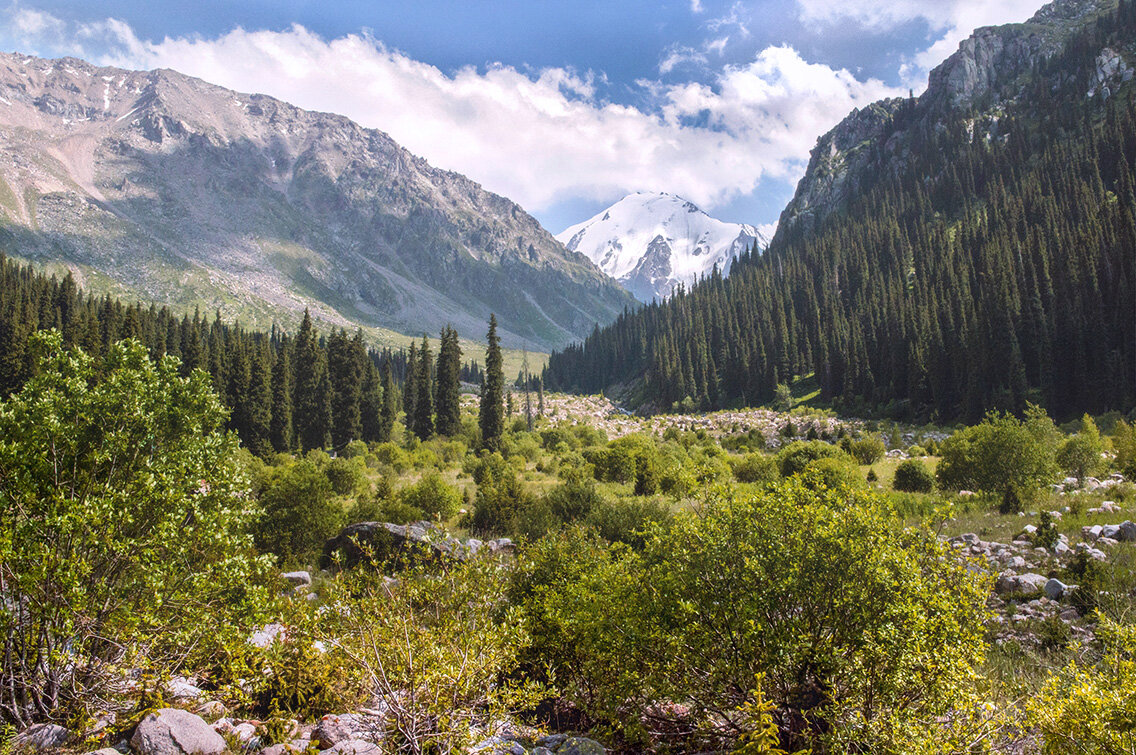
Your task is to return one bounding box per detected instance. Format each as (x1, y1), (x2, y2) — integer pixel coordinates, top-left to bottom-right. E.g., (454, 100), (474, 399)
(546, 2), (1136, 419)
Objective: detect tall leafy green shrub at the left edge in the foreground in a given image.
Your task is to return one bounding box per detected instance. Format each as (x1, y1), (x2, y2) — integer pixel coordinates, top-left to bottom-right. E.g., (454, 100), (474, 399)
(0, 333), (262, 725)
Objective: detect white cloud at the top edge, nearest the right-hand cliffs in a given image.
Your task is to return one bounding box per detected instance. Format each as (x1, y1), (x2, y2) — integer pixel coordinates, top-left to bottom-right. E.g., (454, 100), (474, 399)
(797, 0), (1049, 85)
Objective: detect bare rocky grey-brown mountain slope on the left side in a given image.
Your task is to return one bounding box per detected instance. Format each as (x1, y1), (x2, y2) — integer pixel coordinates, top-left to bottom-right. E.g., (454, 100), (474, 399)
(0, 54), (633, 349)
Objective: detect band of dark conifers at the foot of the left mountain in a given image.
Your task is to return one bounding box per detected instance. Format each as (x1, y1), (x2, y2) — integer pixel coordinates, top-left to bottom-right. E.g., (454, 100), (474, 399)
(0, 255), (482, 456)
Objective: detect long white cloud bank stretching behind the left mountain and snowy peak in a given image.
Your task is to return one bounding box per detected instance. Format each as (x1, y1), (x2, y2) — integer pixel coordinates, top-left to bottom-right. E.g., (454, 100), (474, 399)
(2, 8), (896, 217)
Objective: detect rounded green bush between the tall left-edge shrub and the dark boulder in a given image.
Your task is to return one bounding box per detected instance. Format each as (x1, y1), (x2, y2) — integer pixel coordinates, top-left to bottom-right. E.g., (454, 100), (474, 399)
(256, 459), (346, 564)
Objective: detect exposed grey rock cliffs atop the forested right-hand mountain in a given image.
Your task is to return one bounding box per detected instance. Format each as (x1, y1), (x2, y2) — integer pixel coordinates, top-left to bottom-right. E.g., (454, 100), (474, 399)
(775, 0), (1117, 240)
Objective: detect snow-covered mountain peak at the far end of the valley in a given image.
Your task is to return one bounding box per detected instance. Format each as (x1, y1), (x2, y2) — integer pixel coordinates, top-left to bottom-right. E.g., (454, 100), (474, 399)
(557, 192), (767, 302)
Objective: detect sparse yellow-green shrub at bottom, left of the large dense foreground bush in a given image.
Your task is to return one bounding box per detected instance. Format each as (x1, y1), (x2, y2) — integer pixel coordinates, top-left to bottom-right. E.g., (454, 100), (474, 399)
(332, 559), (543, 753)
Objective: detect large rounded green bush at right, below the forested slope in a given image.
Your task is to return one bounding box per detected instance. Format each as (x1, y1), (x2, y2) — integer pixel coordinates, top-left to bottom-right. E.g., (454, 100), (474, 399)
(936, 404), (1056, 509)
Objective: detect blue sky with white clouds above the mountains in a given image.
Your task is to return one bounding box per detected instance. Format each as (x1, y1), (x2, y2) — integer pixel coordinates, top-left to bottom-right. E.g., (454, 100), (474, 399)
(0, 0), (1044, 233)
